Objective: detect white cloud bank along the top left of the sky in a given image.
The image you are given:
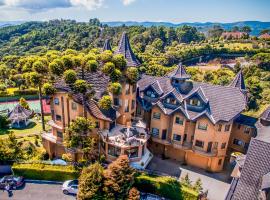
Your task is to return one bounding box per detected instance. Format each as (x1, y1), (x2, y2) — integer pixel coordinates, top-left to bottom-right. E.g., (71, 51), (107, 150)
(0, 0), (104, 11)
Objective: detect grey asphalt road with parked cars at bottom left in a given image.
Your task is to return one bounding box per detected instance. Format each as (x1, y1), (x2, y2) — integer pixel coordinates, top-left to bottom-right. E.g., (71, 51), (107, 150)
(0, 182), (76, 200)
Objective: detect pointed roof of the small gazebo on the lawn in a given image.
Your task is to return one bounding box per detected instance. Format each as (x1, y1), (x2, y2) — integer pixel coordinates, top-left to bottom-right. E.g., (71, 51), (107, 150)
(8, 104), (33, 121)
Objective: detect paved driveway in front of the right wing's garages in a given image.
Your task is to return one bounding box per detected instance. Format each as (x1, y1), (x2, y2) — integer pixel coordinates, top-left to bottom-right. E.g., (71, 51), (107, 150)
(147, 156), (230, 200)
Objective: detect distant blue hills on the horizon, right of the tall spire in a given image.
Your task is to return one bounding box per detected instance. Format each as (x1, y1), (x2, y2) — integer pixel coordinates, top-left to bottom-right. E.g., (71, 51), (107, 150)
(103, 21), (270, 35)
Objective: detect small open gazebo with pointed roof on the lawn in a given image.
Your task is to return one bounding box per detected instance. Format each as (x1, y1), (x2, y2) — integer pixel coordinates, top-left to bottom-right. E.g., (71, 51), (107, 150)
(8, 104), (33, 128)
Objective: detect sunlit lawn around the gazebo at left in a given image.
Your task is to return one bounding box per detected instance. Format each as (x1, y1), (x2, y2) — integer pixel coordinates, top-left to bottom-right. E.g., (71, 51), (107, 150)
(0, 116), (50, 139)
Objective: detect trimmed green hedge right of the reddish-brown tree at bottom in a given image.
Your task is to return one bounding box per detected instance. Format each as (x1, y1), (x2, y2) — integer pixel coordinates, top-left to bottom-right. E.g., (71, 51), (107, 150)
(135, 174), (198, 200)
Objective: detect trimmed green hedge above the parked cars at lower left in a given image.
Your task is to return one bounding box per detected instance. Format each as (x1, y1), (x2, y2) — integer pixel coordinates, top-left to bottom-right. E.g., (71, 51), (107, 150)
(12, 163), (79, 181)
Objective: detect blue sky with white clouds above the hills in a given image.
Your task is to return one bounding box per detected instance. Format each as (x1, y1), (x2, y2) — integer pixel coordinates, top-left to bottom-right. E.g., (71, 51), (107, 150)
(0, 0), (270, 23)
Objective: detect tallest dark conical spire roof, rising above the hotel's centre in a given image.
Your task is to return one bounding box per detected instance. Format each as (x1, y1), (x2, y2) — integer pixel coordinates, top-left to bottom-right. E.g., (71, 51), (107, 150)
(115, 32), (141, 67)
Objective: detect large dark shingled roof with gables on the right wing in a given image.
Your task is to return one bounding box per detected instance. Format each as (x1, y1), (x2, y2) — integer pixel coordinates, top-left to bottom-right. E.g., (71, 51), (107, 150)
(137, 75), (246, 123)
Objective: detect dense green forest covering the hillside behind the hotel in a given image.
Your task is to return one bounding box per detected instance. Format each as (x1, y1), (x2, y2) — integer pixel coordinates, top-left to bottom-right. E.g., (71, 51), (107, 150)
(0, 19), (270, 116)
